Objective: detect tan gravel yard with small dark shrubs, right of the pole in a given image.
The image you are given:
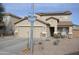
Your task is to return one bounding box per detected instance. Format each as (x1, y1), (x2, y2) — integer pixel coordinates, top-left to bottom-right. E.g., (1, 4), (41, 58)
(34, 38), (79, 55)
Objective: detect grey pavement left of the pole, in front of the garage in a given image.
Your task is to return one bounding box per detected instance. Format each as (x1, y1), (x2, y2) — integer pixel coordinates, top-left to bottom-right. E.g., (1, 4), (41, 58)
(0, 37), (27, 55)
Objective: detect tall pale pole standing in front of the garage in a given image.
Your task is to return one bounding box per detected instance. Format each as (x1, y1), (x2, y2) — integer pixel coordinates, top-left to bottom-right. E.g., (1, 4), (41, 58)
(28, 3), (35, 55)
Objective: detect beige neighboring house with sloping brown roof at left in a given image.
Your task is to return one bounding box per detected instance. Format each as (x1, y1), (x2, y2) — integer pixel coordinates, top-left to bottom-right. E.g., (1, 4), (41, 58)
(3, 13), (21, 35)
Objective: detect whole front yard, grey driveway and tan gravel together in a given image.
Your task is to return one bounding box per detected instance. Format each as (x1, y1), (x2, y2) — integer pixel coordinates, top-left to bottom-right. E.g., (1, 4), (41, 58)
(0, 36), (79, 55)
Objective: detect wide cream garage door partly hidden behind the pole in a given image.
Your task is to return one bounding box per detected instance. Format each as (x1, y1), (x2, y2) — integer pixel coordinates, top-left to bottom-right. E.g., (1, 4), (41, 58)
(18, 26), (42, 38)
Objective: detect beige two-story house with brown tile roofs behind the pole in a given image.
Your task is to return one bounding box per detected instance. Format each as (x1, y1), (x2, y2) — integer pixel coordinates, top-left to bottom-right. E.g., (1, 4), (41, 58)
(15, 11), (73, 38)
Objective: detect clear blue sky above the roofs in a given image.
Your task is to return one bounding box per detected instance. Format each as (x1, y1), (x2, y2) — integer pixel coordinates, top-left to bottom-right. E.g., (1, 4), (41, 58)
(3, 3), (79, 24)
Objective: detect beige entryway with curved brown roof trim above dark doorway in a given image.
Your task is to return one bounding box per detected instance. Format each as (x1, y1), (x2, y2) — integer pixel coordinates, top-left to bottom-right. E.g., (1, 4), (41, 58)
(46, 17), (59, 37)
